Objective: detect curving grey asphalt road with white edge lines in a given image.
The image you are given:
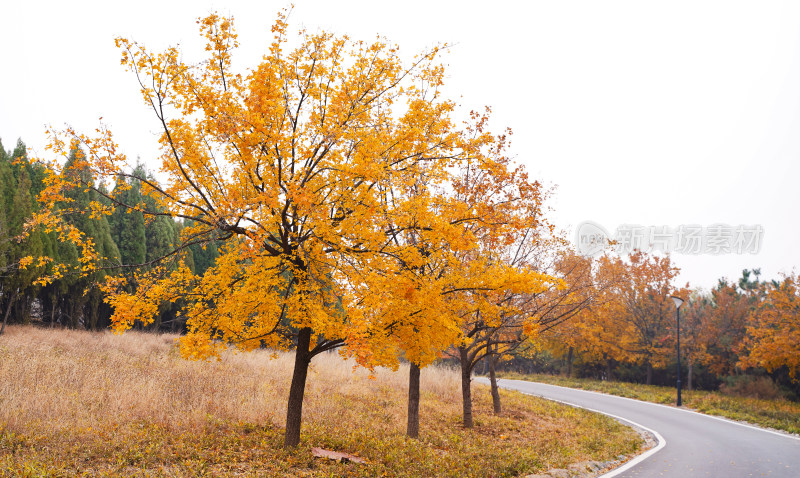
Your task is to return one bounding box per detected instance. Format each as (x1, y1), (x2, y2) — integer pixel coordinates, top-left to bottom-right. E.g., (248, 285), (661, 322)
(475, 378), (800, 478)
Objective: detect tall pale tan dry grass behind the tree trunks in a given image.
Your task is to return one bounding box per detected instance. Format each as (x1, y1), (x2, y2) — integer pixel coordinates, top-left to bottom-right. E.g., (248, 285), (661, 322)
(0, 326), (460, 432)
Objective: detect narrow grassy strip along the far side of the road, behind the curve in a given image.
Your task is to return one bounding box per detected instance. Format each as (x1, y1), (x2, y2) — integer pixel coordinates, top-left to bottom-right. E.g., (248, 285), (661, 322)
(499, 373), (800, 433)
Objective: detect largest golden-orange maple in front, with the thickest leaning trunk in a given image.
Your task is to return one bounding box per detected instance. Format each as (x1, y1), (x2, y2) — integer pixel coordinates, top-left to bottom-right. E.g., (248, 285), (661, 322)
(29, 13), (552, 446)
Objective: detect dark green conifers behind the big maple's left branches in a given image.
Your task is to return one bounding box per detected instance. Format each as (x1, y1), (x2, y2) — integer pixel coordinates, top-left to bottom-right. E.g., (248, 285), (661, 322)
(0, 140), (218, 331)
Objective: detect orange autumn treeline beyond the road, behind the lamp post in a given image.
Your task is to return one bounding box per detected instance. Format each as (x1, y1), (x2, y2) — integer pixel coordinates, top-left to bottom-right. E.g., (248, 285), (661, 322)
(500, 269), (800, 401)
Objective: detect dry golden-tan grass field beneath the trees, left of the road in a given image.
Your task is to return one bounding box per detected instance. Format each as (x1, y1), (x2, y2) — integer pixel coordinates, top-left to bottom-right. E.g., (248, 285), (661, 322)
(0, 326), (641, 478)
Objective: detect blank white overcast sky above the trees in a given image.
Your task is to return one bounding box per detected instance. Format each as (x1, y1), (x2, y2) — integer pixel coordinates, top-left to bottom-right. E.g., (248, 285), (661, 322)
(0, 0), (800, 288)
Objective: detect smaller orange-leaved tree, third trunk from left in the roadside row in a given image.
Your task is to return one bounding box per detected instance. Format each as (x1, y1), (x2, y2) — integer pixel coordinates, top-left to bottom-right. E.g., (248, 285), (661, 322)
(450, 165), (560, 428)
